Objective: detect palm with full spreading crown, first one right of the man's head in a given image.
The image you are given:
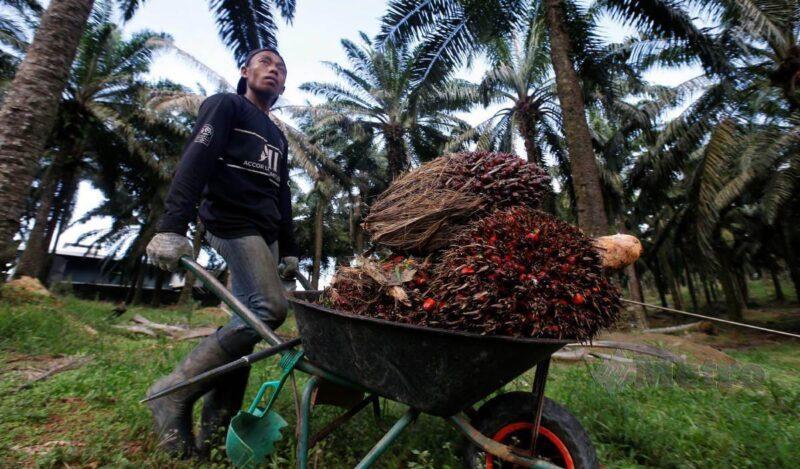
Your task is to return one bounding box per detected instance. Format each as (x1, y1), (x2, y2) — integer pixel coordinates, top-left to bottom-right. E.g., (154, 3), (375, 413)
(298, 33), (470, 181)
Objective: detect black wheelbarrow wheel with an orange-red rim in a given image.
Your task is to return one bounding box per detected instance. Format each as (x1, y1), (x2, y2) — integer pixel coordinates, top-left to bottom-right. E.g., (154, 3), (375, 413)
(464, 392), (600, 469)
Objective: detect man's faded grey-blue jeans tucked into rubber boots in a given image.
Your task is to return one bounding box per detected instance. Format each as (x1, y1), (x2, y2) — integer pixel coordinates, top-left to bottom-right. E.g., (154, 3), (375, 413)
(206, 232), (288, 358)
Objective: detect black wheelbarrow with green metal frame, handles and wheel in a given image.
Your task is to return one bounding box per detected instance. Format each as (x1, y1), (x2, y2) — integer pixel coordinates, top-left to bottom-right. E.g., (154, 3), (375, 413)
(154, 258), (599, 469)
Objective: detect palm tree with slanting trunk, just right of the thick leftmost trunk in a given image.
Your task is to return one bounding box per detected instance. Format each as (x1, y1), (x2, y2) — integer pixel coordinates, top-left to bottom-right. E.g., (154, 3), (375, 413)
(16, 8), (167, 277)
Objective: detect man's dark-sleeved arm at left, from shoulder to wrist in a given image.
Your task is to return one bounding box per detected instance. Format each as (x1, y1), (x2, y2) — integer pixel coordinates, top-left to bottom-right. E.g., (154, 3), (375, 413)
(158, 94), (235, 235)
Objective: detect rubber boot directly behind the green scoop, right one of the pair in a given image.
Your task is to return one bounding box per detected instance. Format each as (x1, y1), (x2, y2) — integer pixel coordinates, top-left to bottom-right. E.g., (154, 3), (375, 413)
(196, 368), (250, 459)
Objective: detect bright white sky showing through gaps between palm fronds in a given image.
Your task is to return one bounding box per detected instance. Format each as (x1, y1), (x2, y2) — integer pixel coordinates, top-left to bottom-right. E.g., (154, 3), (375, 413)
(53, 0), (699, 264)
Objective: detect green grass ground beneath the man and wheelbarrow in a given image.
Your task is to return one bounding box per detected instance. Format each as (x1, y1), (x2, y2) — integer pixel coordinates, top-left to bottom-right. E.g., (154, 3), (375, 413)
(0, 288), (800, 468)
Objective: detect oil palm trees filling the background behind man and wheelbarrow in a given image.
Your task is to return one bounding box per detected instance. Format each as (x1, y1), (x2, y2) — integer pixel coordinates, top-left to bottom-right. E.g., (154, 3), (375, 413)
(0, 0), (800, 317)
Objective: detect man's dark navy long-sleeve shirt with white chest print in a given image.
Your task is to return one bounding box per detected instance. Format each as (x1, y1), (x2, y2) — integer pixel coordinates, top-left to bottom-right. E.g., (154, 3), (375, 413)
(158, 93), (297, 257)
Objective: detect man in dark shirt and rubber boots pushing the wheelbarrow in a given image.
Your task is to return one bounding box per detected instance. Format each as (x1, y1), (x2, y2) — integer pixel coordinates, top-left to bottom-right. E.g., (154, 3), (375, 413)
(147, 48), (297, 457)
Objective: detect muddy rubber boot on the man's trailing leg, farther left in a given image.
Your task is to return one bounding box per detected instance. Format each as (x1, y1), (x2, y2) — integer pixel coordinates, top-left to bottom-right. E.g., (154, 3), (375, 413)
(147, 334), (232, 458)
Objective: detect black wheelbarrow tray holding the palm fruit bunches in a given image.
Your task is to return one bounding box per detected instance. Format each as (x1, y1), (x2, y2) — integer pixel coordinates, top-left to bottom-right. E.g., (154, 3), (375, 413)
(289, 295), (571, 417)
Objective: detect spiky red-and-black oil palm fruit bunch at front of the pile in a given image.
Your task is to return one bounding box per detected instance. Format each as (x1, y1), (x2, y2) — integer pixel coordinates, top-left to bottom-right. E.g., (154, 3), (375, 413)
(418, 207), (620, 340)
